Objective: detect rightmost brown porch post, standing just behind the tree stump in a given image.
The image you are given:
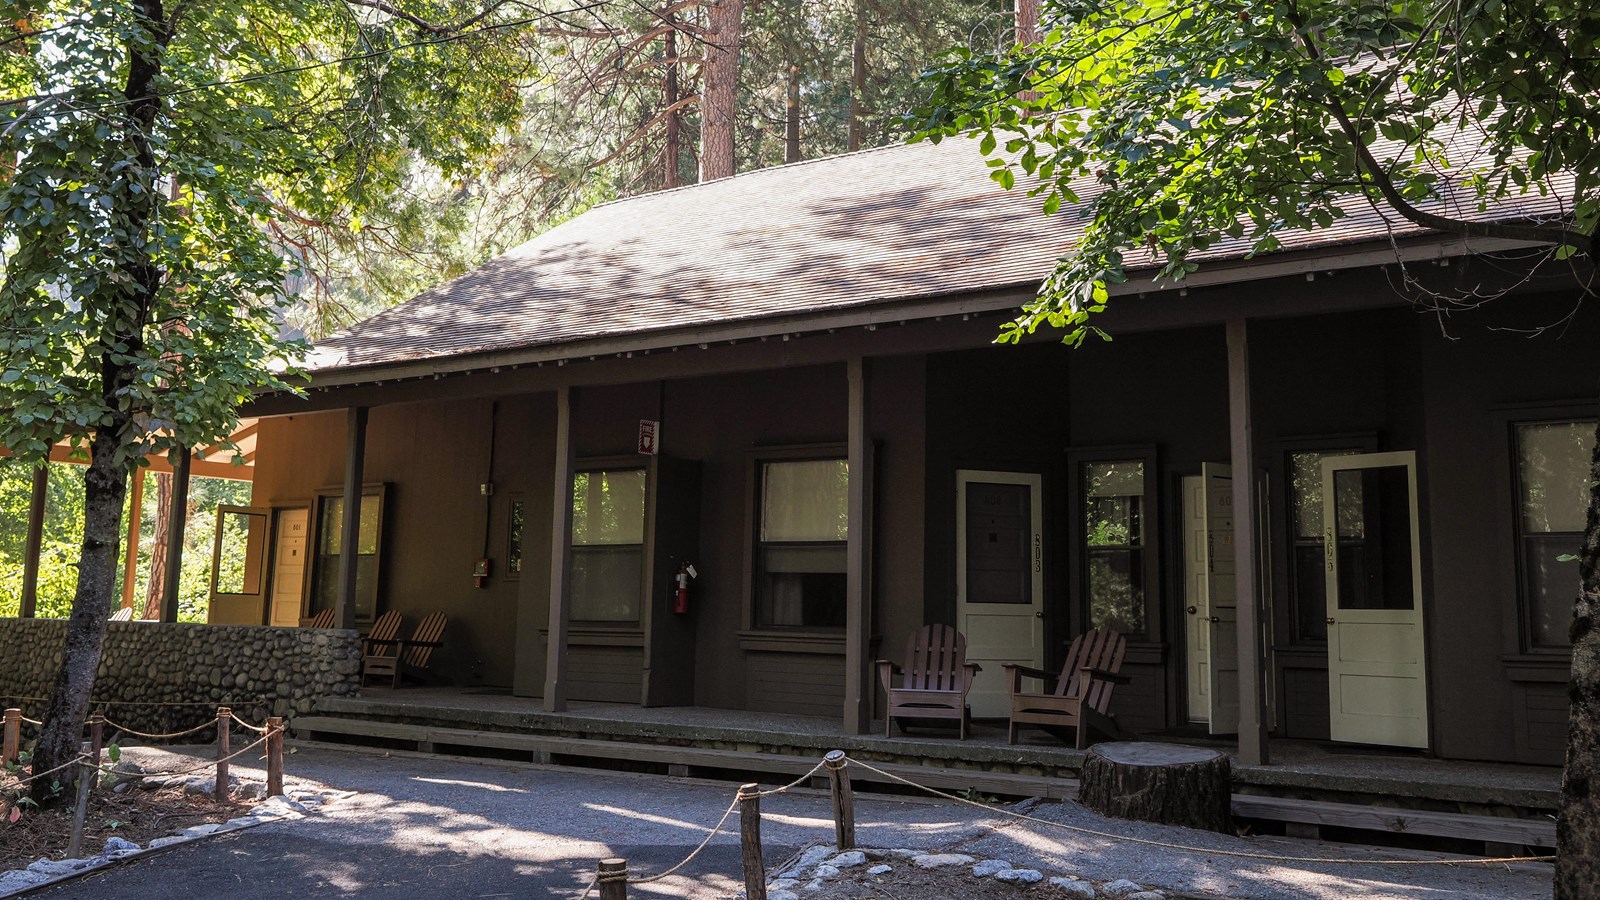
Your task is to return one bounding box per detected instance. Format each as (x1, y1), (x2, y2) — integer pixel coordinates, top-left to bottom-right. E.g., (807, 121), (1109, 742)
(1227, 319), (1267, 765)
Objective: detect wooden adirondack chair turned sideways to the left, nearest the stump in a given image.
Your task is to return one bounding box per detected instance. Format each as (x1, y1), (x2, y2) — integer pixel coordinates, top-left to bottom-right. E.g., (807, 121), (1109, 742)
(1005, 628), (1128, 749)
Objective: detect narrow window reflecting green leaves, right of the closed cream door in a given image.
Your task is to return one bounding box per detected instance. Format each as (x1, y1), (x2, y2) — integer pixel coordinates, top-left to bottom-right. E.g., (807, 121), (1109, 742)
(1080, 460), (1150, 636)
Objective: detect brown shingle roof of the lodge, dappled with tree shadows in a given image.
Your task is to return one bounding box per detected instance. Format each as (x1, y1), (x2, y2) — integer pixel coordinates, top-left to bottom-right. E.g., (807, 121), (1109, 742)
(307, 132), (1560, 372)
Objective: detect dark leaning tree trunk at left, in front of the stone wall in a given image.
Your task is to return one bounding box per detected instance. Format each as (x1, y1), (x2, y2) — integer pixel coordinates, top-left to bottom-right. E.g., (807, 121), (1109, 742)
(30, 0), (171, 806)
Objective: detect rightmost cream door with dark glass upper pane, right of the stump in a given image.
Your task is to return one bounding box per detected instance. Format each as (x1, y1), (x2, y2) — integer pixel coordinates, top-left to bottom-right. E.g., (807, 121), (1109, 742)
(1322, 452), (1427, 748)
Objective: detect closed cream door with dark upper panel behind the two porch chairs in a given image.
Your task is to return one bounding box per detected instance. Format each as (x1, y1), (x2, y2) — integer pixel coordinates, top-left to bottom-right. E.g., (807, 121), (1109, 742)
(955, 469), (1045, 719)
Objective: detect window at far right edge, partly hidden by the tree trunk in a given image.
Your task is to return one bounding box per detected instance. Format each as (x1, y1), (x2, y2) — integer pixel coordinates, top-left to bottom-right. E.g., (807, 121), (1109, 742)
(1515, 420), (1595, 650)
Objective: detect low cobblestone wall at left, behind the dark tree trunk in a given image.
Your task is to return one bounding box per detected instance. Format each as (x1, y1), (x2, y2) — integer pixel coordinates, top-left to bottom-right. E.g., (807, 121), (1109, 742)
(0, 618), (362, 740)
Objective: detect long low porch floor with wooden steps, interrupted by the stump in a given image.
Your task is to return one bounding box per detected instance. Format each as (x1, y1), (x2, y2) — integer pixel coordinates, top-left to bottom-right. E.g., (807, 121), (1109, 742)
(294, 687), (1560, 852)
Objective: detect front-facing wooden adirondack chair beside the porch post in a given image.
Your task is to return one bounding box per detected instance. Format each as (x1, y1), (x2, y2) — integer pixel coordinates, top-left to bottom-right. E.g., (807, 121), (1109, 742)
(878, 625), (981, 740)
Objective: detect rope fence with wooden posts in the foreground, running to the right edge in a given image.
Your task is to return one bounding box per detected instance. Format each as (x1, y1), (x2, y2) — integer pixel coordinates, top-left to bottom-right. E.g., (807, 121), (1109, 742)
(579, 749), (1555, 900)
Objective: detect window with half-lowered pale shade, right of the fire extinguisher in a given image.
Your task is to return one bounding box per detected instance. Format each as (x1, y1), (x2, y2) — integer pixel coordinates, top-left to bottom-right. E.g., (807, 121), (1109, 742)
(754, 460), (850, 628)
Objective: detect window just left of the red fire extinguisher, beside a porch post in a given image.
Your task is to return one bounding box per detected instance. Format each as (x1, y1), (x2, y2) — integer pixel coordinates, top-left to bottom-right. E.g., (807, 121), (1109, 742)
(570, 469), (645, 625)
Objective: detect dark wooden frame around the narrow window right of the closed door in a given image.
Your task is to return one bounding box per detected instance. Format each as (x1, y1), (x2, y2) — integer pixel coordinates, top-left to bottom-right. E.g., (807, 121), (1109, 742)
(1067, 444), (1166, 645)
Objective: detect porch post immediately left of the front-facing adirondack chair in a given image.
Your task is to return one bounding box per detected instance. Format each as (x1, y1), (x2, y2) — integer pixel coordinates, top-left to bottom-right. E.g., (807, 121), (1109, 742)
(845, 357), (872, 735)
